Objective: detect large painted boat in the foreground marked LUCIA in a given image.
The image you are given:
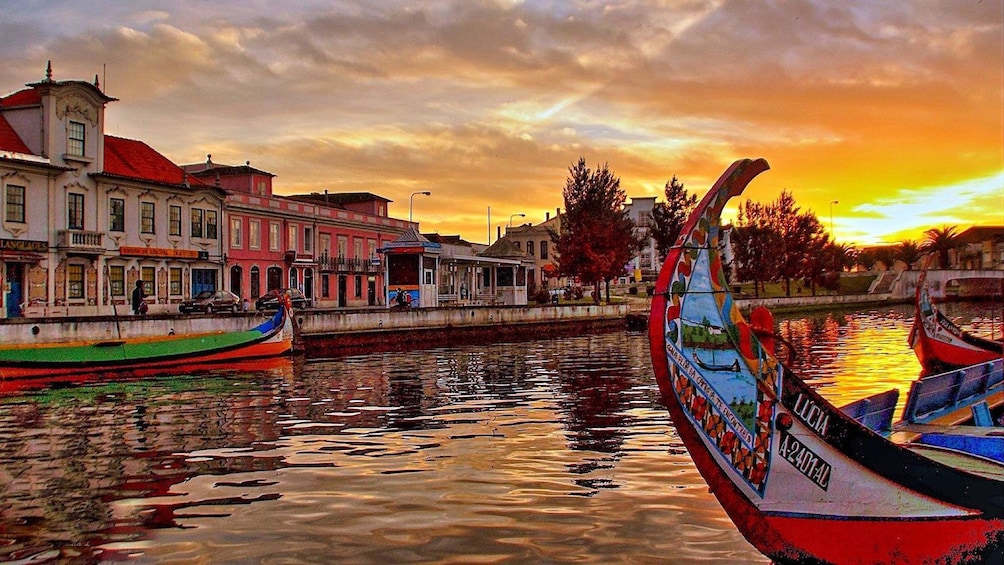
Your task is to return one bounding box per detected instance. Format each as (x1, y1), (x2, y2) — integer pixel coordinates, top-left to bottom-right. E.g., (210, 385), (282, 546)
(649, 160), (1004, 563)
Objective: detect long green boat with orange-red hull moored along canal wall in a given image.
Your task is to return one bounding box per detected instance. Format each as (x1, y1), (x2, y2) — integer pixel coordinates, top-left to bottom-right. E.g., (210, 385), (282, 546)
(0, 307), (293, 381)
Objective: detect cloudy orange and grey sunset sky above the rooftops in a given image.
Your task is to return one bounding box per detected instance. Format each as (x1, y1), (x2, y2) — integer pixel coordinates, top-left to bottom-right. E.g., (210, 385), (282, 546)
(0, 0), (1004, 245)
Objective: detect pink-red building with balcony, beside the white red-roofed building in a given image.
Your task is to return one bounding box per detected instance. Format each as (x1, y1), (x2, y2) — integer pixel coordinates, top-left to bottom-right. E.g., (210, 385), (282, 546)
(184, 157), (412, 307)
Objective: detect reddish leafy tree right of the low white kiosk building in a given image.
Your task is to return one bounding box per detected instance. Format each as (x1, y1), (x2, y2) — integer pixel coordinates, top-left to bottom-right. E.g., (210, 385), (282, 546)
(551, 158), (640, 302)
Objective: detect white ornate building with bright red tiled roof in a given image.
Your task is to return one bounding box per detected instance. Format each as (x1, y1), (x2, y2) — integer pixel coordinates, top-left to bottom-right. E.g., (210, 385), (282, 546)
(0, 67), (225, 317)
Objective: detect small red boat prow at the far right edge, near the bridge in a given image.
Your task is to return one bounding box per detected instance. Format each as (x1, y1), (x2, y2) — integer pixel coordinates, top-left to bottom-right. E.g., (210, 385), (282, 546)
(910, 268), (1004, 372)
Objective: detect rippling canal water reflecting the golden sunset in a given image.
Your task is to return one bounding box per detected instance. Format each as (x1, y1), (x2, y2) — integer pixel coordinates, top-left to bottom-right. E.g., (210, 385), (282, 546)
(0, 304), (1000, 563)
